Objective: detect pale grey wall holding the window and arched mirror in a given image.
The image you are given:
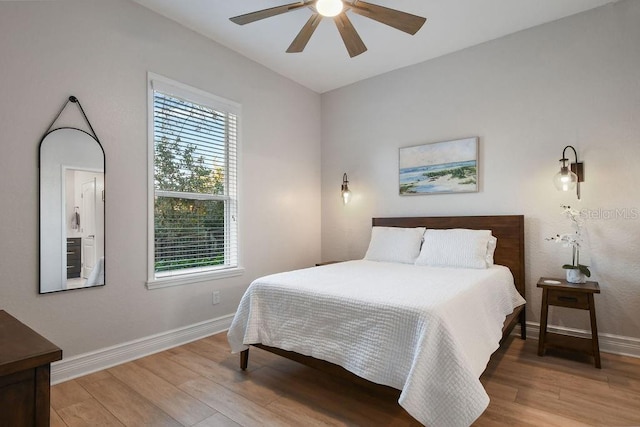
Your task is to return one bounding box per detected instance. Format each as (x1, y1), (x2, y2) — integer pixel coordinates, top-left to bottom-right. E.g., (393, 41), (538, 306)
(0, 0), (321, 357)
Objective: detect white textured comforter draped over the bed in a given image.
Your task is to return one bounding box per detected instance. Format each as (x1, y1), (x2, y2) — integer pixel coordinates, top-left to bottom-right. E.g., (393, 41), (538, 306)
(228, 260), (525, 427)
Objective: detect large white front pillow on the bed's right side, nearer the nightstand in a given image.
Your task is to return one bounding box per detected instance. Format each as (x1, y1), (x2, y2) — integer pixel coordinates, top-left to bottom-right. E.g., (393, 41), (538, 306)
(415, 228), (493, 268)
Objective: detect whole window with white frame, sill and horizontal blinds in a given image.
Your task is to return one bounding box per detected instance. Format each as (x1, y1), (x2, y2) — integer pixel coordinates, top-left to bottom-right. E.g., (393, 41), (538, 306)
(147, 74), (242, 288)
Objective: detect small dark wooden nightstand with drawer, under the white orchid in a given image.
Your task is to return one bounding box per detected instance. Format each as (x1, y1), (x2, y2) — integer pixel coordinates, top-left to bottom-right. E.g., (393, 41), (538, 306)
(538, 277), (600, 368)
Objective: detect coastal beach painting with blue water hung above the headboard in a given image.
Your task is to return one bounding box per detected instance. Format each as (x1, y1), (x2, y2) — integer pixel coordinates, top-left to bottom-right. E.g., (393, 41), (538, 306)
(400, 137), (478, 195)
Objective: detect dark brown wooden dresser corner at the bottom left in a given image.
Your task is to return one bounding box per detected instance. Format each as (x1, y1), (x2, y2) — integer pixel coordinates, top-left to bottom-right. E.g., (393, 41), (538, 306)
(0, 310), (62, 427)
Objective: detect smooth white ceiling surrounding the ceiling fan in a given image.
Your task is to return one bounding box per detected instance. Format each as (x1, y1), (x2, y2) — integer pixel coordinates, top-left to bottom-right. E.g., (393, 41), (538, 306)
(134, 0), (617, 93)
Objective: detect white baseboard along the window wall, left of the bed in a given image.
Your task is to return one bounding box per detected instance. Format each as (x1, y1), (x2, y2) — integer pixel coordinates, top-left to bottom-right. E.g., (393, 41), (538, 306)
(51, 314), (233, 384)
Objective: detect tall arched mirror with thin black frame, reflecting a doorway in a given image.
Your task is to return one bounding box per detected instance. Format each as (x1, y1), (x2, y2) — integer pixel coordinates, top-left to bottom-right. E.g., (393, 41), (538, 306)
(39, 99), (105, 294)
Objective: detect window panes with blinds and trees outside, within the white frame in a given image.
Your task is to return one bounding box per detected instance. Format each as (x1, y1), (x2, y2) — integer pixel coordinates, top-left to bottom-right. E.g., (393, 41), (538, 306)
(153, 91), (237, 275)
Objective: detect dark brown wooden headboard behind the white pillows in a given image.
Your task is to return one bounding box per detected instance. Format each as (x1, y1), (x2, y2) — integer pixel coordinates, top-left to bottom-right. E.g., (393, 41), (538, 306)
(372, 215), (526, 299)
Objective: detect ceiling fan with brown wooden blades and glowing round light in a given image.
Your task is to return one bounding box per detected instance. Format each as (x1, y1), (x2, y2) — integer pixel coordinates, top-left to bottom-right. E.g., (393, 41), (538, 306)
(229, 0), (427, 58)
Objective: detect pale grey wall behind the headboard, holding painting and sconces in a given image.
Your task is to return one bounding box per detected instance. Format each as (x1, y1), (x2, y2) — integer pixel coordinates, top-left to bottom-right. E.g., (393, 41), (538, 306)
(322, 1), (640, 338)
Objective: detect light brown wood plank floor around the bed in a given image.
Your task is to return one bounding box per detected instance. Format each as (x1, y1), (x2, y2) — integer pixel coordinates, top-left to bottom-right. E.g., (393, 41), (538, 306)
(51, 334), (640, 427)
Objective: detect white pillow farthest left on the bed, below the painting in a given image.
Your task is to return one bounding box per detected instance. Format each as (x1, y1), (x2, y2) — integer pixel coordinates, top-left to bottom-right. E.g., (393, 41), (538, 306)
(364, 227), (425, 264)
